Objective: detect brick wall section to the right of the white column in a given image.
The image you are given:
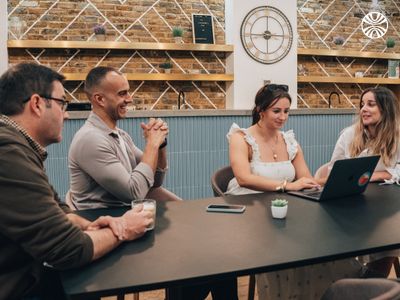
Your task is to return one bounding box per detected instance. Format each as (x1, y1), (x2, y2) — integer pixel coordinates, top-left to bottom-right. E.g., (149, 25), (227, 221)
(297, 0), (400, 107)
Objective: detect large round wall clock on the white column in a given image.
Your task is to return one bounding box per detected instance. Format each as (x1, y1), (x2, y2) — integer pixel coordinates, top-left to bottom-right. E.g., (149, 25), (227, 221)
(240, 6), (293, 64)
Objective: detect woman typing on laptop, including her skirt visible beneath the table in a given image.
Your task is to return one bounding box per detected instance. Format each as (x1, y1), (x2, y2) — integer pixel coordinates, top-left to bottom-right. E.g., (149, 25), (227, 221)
(226, 84), (361, 300)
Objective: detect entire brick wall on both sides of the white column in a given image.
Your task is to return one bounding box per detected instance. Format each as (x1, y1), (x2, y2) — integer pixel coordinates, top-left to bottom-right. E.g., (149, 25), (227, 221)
(8, 0), (400, 109)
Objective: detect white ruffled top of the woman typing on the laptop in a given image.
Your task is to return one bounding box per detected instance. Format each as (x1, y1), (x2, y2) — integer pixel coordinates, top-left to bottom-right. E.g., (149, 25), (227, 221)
(225, 123), (298, 195)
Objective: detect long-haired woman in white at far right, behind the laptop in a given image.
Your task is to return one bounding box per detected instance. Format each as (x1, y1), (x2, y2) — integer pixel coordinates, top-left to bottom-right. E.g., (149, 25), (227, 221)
(324, 87), (400, 277)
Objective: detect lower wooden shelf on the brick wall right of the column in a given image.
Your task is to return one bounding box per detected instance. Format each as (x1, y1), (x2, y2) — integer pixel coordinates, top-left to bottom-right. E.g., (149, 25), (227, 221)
(297, 76), (400, 84)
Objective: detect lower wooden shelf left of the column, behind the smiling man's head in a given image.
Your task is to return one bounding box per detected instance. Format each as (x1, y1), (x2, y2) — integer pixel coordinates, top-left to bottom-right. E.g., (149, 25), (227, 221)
(63, 73), (234, 81)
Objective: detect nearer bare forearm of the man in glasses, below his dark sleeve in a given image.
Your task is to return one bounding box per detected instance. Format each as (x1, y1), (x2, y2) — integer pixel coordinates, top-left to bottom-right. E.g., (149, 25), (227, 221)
(85, 228), (122, 260)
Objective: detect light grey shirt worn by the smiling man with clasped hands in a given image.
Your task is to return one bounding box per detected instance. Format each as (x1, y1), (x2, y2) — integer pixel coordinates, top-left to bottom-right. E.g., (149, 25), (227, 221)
(68, 112), (165, 209)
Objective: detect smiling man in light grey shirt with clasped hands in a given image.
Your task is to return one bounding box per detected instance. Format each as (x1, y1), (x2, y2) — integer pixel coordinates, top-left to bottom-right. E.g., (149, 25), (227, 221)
(68, 67), (180, 209)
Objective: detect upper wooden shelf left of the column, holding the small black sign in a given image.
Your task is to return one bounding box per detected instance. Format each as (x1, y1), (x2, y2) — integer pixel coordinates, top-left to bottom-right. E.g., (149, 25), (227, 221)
(7, 40), (233, 52)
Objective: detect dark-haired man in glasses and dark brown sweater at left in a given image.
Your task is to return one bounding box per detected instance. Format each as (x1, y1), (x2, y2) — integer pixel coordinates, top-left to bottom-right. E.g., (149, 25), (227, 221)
(0, 63), (152, 299)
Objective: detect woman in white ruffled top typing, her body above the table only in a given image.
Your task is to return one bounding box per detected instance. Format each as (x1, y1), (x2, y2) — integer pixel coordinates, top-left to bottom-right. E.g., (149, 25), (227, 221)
(226, 84), (318, 195)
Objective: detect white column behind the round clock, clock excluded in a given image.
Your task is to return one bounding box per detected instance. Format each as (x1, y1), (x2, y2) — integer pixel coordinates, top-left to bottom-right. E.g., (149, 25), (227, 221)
(225, 0), (297, 109)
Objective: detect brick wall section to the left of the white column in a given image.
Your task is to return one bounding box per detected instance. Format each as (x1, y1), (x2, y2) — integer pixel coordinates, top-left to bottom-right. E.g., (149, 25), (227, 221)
(8, 0), (226, 109)
